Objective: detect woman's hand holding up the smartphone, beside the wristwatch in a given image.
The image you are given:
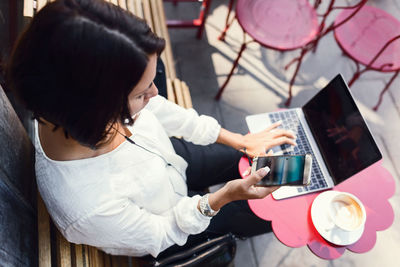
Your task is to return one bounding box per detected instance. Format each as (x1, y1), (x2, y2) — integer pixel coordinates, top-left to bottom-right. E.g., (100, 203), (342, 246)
(208, 167), (279, 213)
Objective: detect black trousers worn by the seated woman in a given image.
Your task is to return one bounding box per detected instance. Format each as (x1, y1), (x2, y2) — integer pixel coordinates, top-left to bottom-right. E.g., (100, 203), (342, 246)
(155, 138), (271, 257)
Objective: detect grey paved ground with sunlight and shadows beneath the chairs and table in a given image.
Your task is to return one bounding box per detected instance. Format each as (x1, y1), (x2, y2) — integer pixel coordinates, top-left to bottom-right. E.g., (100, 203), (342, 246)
(166, 0), (400, 267)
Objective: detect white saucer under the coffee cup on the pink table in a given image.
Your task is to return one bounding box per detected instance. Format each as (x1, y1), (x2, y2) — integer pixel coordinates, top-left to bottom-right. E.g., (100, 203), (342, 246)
(311, 191), (364, 246)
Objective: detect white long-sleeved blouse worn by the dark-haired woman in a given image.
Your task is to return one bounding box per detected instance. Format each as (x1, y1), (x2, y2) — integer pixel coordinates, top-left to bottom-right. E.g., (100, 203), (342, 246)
(35, 96), (221, 257)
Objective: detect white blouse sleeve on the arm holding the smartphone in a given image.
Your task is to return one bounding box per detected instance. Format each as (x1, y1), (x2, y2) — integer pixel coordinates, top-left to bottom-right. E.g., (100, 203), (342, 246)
(66, 195), (210, 257)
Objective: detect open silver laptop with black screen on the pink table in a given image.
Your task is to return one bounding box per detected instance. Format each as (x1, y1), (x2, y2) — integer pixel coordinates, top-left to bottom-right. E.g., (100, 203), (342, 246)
(246, 74), (382, 199)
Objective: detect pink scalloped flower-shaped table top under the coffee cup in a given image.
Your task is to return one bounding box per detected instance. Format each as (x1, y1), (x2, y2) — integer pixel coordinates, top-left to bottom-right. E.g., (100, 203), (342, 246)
(239, 157), (395, 259)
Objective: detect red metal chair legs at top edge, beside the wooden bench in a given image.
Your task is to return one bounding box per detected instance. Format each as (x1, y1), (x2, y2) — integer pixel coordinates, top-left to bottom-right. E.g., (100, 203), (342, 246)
(164, 0), (211, 39)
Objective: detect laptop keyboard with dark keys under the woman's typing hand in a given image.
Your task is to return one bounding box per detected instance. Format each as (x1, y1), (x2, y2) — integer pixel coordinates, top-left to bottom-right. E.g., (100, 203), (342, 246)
(269, 110), (328, 193)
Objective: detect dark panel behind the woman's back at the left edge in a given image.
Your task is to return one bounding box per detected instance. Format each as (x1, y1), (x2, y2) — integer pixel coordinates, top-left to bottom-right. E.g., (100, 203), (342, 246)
(0, 84), (38, 266)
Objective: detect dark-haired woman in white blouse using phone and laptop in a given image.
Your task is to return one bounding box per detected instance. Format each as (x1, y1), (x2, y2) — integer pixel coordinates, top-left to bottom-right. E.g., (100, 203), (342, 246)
(7, 0), (295, 257)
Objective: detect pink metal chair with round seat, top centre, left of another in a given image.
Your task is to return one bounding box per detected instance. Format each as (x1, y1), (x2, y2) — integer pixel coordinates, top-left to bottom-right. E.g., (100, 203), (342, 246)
(215, 0), (367, 106)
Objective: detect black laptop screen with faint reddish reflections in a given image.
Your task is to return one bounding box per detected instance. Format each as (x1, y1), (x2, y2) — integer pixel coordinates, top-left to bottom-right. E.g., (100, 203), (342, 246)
(302, 74), (382, 184)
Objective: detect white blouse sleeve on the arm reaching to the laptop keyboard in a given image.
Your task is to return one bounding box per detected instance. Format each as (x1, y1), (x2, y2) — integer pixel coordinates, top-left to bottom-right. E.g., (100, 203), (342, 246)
(146, 95), (221, 145)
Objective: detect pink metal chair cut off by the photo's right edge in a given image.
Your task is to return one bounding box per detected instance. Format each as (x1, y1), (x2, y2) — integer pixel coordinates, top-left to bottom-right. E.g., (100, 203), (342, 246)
(334, 5), (400, 110)
